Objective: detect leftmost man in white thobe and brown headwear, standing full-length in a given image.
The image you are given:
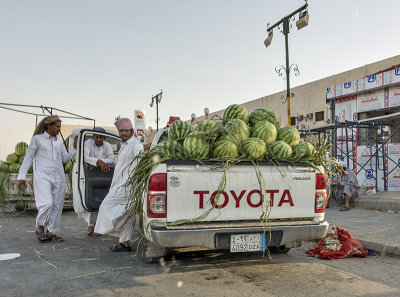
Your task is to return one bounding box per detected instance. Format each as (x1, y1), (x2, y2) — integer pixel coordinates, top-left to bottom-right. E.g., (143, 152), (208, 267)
(17, 115), (76, 242)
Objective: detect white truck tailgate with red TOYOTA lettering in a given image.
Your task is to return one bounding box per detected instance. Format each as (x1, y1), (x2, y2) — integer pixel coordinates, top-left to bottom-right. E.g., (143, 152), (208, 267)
(167, 164), (316, 222)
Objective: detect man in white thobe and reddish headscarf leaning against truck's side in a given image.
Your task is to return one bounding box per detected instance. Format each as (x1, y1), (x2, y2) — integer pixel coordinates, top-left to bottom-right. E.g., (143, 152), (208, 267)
(95, 118), (143, 252)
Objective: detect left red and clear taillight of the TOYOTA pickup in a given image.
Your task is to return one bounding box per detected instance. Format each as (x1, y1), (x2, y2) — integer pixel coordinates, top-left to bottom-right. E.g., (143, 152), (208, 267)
(147, 173), (167, 218)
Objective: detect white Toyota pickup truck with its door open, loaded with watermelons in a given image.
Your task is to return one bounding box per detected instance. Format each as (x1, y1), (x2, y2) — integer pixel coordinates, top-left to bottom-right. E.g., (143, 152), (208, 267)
(72, 129), (329, 262)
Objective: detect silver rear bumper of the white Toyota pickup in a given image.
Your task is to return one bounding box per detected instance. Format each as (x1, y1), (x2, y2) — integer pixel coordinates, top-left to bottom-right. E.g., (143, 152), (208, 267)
(149, 221), (329, 249)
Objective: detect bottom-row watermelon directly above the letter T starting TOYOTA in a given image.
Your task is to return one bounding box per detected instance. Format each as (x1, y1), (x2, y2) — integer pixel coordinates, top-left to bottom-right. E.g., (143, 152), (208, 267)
(183, 131), (211, 159)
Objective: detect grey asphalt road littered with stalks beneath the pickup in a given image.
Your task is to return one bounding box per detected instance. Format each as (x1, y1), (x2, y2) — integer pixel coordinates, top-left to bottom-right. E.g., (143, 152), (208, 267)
(0, 211), (400, 297)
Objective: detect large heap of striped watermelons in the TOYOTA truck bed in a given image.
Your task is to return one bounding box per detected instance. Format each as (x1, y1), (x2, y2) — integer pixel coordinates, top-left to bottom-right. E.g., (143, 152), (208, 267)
(155, 104), (315, 161)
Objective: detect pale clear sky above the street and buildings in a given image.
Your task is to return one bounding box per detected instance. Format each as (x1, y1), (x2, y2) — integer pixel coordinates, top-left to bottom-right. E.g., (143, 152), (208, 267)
(0, 0), (400, 160)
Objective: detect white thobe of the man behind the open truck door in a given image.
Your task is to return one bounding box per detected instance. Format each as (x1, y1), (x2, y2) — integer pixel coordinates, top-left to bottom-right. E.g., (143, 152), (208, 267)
(78, 139), (115, 226)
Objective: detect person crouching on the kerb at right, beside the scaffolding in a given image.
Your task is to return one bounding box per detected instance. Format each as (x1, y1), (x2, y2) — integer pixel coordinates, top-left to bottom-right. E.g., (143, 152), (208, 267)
(331, 161), (360, 211)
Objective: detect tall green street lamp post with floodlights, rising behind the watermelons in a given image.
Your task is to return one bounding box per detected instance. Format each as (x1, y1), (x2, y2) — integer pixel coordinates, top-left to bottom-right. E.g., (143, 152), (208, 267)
(264, 1), (309, 126)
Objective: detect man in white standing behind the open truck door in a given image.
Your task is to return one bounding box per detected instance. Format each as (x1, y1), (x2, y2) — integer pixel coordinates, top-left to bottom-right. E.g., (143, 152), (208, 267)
(78, 127), (114, 236)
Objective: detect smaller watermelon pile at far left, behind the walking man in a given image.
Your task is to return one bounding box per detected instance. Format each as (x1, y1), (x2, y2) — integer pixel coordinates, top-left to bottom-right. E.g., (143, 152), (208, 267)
(0, 142), (75, 174)
